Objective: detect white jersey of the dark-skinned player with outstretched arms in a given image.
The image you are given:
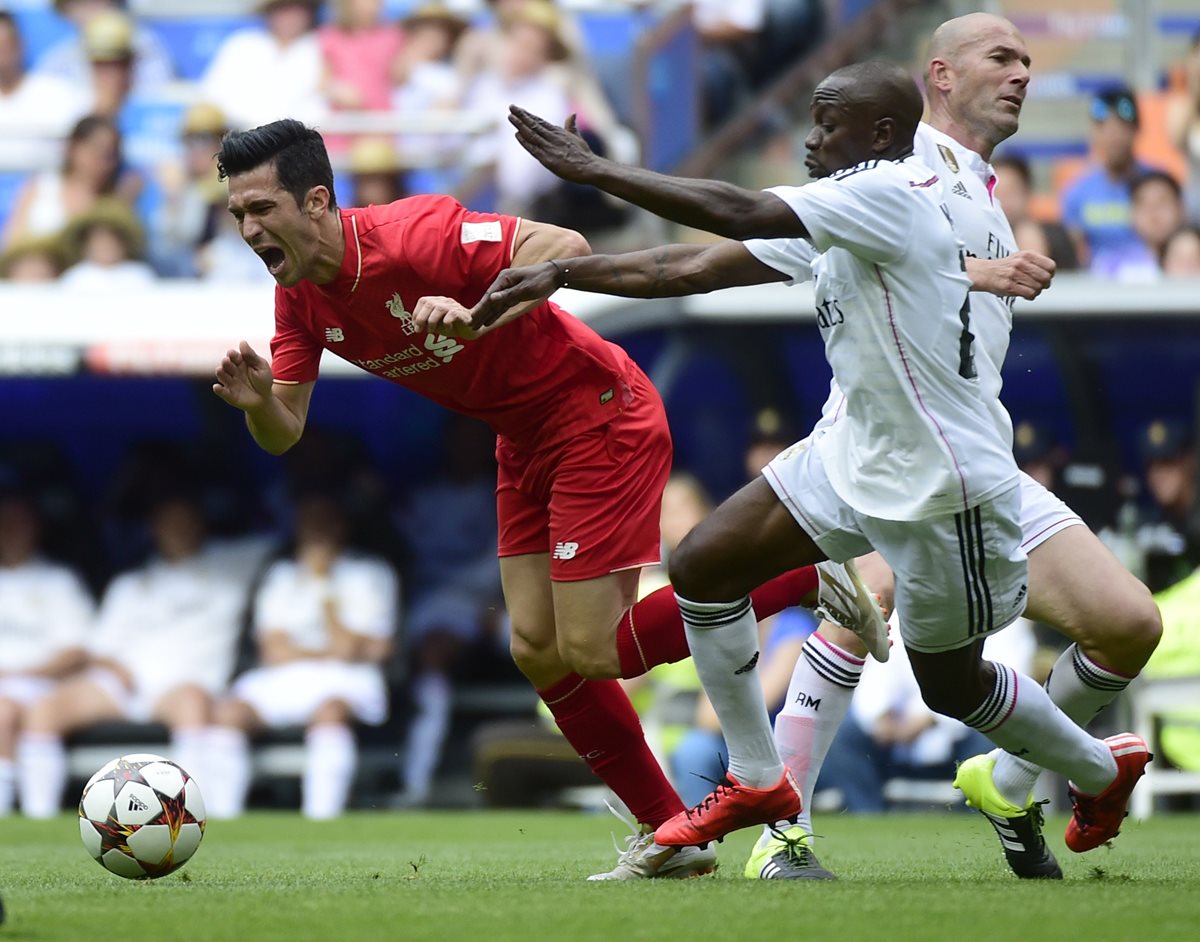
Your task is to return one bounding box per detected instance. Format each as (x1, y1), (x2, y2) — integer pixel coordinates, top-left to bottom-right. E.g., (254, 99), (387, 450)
(746, 157), (1016, 521)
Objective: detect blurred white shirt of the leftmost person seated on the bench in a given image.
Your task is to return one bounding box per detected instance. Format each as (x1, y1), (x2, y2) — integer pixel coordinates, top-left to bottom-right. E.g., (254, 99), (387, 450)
(0, 558), (95, 673)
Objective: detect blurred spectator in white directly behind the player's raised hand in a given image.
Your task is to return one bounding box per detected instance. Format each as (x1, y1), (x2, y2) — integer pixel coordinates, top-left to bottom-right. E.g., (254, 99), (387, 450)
(464, 0), (571, 216)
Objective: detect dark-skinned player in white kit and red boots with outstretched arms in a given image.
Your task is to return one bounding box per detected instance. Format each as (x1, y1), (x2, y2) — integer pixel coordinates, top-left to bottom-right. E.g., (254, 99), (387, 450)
(472, 62), (1146, 846)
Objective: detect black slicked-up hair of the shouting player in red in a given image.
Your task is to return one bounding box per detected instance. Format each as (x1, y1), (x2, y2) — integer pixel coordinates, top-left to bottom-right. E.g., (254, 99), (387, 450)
(217, 118), (337, 209)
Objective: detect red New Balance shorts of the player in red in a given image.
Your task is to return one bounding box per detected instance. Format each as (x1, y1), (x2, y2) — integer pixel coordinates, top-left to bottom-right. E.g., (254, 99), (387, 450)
(496, 371), (672, 582)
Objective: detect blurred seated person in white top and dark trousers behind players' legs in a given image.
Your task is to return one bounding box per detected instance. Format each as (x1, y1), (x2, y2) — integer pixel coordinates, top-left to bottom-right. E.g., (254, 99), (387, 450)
(820, 619), (1037, 814)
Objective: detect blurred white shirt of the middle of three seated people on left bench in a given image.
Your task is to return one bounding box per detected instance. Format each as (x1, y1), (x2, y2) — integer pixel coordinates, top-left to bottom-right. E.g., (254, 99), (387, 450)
(89, 545), (259, 701)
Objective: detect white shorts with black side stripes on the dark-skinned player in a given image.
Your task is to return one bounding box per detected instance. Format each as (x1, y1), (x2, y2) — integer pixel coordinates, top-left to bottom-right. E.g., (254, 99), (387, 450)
(763, 443), (1028, 653)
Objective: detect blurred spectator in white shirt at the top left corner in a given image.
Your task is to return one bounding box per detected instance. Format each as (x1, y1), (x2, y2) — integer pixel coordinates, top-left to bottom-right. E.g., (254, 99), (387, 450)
(0, 10), (83, 169)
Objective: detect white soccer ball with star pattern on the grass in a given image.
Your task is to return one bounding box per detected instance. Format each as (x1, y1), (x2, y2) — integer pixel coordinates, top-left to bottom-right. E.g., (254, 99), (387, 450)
(79, 752), (204, 880)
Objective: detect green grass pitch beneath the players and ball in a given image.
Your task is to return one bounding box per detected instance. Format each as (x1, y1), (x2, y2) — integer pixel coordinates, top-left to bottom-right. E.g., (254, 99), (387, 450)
(0, 812), (1200, 942)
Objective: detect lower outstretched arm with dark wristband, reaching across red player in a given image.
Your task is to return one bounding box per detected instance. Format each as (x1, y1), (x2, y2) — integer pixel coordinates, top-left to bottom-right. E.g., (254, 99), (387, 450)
(470, 241), (787, 326)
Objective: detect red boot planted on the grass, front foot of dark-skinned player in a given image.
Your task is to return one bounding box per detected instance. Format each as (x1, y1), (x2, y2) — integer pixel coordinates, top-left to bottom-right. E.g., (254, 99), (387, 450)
(654, 769), (803, 847)
